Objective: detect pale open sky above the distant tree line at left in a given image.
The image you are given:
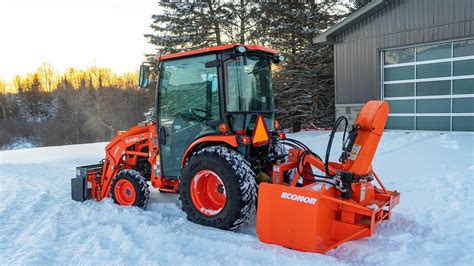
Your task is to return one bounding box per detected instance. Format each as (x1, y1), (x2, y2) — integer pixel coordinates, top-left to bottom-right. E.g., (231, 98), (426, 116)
(0, 0), (158, 81)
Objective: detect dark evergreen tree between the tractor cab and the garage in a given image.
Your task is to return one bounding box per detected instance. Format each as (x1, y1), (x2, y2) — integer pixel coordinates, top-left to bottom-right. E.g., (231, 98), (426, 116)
(260, 1), (346, 131)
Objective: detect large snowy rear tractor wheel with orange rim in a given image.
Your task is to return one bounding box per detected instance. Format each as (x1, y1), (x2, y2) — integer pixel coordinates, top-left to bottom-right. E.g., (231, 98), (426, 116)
(179, 146), (257, 230)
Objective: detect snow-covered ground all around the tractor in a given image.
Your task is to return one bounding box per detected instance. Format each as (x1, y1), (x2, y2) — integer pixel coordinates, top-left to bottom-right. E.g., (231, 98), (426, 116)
(0, 132), (474, 265)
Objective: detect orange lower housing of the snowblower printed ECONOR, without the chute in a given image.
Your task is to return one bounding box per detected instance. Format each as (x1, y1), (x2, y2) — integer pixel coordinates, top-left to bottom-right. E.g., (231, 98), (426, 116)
(257, 183), (399, 253)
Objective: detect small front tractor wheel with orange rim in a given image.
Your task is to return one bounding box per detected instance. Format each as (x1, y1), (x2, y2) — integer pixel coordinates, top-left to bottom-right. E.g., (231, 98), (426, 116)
(110, 169), (150, 208)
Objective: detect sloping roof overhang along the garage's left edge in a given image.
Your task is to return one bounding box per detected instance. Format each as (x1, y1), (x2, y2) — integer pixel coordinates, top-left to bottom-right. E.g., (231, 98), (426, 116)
(313, 0), (392, 43)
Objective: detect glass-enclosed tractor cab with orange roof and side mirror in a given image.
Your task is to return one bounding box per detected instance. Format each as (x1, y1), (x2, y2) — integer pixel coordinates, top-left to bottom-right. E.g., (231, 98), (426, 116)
(140, 45), (284, 178)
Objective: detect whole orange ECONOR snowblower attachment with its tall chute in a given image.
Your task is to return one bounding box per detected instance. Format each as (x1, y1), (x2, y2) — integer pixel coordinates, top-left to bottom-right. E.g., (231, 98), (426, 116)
(257, 101), (400, 253)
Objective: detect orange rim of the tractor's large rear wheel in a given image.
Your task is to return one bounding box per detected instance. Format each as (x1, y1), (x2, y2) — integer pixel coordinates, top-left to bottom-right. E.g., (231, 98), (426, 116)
(190, 170), (227, 216)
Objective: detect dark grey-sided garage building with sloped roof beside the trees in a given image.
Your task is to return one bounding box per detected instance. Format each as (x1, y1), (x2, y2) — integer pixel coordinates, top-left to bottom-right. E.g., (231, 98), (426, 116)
(313, 0), (474, 132)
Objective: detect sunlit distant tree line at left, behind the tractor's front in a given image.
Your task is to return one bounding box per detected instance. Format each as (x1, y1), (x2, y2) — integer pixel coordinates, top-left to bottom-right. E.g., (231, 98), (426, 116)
(0, 64), (154, 148)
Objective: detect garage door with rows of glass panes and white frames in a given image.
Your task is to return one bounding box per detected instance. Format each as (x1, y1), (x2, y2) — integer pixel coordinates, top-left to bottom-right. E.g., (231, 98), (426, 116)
(381, 39), (474, 131)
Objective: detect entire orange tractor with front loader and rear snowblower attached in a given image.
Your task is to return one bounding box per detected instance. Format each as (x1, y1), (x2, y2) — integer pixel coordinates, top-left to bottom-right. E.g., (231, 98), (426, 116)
(71, 44), (400, 253)
